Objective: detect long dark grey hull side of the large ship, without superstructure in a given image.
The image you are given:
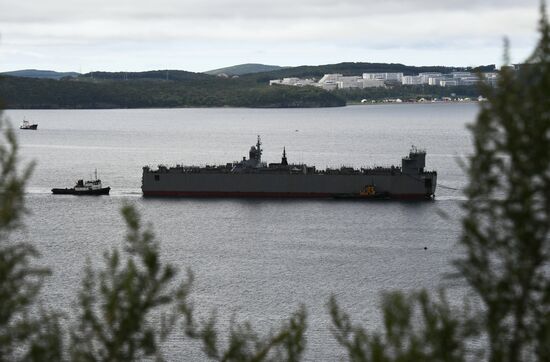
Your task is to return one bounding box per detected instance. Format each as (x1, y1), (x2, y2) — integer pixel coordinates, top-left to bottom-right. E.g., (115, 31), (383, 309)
(142, 169), (437, 200)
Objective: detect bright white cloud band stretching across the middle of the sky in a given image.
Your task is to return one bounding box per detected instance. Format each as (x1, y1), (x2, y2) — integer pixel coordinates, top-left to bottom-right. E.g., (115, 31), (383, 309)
(3, 8), (536, 44)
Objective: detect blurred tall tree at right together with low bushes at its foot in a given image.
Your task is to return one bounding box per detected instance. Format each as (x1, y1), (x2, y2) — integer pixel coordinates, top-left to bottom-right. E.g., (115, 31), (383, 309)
(329, 2), (550, 362)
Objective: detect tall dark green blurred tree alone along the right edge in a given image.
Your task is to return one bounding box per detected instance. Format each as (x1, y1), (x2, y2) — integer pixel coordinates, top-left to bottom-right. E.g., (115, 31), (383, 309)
(457, 4), (550, 361)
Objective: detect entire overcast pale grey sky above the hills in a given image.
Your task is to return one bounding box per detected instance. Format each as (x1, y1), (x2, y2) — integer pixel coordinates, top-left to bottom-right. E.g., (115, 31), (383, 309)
(0, 0), (539, 72)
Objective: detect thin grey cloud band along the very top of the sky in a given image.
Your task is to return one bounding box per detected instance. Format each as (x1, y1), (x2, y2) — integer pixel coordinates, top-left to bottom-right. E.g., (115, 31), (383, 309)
(0, 0), (538, 24)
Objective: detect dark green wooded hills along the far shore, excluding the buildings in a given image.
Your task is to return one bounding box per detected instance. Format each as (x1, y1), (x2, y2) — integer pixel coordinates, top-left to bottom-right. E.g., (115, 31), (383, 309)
(0, 63), (494, 109)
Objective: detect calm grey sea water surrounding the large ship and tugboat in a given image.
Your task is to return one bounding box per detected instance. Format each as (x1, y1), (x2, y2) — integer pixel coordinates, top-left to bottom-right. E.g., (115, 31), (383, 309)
(5, 104), (477, 361)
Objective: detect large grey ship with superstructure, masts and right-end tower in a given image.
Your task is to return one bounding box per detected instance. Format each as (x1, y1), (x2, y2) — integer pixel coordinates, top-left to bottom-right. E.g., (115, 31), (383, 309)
(141, 136), (437, 199)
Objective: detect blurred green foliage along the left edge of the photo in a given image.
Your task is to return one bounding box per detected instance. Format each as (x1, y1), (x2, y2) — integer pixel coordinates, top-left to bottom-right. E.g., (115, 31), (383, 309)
(0, 118), (62, 361)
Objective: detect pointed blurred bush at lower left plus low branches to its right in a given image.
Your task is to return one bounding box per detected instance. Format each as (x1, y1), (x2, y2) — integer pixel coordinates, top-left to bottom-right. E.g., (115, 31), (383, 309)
(70, 202), (306, 361)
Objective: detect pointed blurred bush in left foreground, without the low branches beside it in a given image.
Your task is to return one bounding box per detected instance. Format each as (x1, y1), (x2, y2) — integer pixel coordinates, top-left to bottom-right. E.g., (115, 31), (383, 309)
(71, 206), (189, 361)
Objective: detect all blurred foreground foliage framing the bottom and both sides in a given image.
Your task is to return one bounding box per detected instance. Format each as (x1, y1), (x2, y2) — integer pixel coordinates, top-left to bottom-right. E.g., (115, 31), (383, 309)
(0, 6), (550, 362)
